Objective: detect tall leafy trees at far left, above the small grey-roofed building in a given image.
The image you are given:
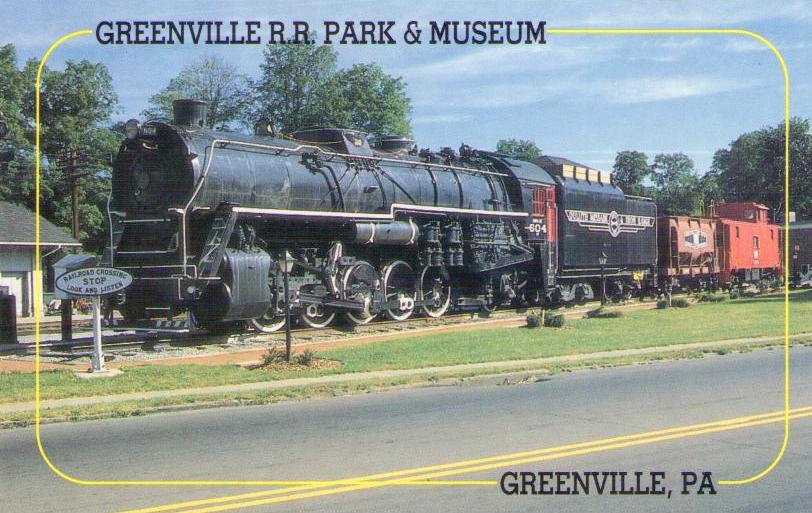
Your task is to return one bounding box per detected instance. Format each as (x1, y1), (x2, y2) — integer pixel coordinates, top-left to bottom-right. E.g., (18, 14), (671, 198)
(0, 45), (119, 250)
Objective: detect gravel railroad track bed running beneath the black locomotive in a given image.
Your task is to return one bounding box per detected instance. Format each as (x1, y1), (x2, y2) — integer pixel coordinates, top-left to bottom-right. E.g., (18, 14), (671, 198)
(0, 301), (655, 357)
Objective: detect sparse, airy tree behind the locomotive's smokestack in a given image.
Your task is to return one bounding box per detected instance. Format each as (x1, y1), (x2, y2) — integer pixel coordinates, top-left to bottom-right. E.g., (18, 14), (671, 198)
(142, 56), (250, 129)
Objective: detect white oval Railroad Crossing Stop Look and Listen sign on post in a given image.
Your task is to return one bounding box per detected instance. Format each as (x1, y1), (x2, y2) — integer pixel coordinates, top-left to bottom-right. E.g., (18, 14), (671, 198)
(54, 267), (133, 372)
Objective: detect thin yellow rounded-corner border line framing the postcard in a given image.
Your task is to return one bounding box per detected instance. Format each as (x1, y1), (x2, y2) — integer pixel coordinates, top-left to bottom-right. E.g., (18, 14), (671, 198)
(34, 28), (790, 488)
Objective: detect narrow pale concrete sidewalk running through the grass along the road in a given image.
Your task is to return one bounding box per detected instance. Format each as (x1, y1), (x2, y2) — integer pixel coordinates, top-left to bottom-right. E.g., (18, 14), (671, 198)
(0, 333), (812, 414)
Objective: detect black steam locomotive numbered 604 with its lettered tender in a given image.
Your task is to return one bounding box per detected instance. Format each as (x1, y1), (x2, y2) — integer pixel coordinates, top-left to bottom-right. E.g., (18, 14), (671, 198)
(105, 100), (657, 332)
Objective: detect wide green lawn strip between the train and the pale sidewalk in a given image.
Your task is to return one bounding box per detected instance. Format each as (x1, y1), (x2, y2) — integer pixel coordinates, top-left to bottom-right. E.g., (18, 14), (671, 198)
(0, 291), (812, 403)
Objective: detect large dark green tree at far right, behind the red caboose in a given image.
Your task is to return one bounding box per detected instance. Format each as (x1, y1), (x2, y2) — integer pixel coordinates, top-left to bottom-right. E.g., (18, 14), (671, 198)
(714, 118), (812, 217)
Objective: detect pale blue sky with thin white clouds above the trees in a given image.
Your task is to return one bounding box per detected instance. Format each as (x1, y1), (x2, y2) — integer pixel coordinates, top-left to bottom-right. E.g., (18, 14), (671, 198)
(0, 0), (812, 172)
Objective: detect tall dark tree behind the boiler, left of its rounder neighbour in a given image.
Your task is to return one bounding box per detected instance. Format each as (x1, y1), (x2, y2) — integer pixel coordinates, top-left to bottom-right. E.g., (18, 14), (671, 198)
(253, 44), (336, 133)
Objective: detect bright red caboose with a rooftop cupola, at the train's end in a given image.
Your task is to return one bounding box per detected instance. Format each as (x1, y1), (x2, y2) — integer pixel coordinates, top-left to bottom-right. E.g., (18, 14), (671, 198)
(715, 202), (781, 284)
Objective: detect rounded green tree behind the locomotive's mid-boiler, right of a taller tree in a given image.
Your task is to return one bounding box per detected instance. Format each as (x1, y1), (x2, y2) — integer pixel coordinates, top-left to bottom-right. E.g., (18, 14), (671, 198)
(312, 64), (412, 136)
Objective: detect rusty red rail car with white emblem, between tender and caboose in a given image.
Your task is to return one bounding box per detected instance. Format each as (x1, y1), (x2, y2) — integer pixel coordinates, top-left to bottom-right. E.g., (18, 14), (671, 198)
(657, 216), (719, 290)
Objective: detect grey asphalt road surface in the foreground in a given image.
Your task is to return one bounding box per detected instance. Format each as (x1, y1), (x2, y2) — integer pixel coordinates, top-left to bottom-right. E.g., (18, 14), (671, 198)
(0, 348), (812, 513)
